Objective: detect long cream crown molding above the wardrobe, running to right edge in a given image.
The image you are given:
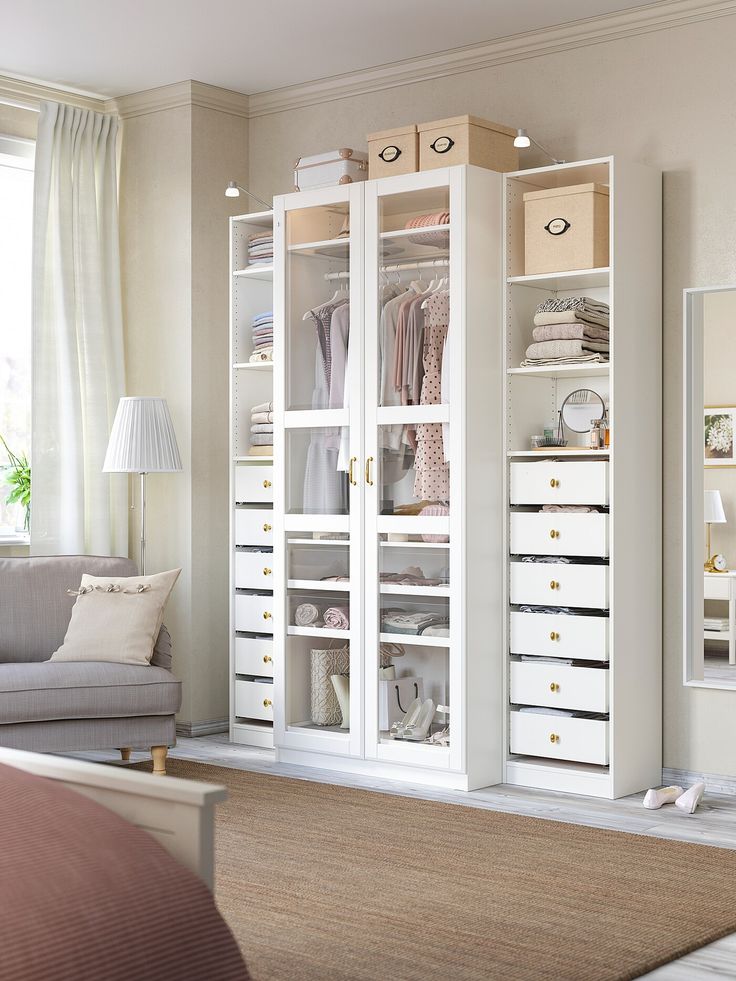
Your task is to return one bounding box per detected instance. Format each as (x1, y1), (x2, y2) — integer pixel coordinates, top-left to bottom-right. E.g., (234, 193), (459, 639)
(249, 0), (736, 118)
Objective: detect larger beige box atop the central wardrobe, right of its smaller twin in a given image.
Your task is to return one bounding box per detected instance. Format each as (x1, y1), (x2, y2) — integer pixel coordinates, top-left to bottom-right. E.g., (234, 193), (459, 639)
(417, 116), (519, 173)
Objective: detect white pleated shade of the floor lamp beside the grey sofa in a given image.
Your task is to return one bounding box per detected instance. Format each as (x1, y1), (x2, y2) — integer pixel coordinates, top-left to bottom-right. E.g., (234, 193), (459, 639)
(102, 396), (182, 473)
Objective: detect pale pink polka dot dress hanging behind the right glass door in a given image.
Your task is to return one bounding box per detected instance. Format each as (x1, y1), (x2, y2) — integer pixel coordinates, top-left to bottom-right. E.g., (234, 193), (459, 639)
(414, 293), (450, 501)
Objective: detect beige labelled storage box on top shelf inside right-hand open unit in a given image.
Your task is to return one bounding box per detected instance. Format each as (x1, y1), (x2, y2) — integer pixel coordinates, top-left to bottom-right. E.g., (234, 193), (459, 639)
(524, 184), (609, 276)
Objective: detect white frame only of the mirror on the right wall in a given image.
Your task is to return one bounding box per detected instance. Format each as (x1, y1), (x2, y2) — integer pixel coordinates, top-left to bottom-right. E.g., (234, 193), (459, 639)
(682, 286), (736, 691)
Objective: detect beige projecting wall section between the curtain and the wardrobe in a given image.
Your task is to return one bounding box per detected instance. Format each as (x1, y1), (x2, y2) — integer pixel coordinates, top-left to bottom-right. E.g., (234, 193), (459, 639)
(120, 105), (248, 724)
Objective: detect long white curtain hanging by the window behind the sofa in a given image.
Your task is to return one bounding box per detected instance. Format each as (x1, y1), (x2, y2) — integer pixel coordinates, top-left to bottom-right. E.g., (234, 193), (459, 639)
(31, 102), (128, 555)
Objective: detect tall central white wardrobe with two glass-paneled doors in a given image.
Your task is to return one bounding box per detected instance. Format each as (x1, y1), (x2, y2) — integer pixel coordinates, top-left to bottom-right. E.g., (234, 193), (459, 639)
(272, 166), (504, 789)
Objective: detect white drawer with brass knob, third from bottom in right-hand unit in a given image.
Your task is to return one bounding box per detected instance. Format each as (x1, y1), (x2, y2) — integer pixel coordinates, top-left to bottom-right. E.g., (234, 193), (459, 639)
(510, 611), (608, 661)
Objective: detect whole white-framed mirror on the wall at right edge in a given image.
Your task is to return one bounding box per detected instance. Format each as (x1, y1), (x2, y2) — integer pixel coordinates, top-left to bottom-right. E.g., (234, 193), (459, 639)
(683, 286), (736, 689)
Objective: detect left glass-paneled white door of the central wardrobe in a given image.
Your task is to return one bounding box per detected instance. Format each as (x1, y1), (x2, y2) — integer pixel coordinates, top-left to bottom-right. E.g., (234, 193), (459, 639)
(273, 187), (363, 755)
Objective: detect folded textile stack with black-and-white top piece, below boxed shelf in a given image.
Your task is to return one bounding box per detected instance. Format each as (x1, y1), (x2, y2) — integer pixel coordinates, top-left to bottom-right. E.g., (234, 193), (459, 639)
(521, 296), (610, 367)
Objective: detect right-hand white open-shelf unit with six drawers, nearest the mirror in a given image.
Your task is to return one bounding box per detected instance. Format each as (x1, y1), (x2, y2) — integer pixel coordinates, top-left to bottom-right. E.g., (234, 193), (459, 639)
(504, 157), (662, 798)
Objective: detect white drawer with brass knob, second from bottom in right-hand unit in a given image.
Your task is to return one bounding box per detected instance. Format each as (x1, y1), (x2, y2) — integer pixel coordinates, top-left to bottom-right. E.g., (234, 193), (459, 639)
(511, 661), (608, 712)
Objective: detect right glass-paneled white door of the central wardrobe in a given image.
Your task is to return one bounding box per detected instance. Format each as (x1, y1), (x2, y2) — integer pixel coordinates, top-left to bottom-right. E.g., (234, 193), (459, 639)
(365, 171), (461, 768)
